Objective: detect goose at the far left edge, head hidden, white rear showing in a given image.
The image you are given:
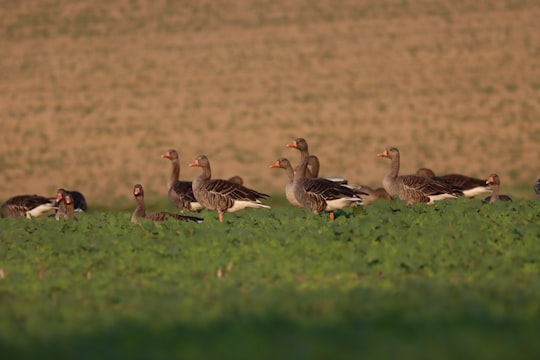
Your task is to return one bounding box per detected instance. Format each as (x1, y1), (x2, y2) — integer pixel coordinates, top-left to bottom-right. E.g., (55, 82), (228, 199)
(2, 195), (54, 219)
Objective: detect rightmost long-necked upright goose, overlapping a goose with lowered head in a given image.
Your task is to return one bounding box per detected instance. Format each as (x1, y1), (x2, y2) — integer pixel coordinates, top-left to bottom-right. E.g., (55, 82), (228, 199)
(377, 147), (463, 205)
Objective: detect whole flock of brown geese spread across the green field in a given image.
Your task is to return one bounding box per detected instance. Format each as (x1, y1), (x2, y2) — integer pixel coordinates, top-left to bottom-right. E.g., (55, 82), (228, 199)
(1, 138), (540, 223)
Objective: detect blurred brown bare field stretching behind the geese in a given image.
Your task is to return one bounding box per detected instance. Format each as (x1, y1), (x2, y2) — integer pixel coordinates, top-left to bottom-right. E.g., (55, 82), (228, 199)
(0, 0), (540, 206)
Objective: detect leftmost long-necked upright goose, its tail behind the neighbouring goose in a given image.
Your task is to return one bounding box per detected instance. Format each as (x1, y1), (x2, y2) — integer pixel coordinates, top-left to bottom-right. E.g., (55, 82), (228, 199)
(161, 149), (204, 212)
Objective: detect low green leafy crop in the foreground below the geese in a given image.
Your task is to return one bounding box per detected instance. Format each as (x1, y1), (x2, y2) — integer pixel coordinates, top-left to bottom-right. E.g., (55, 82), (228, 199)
(0, 199), (540, 359)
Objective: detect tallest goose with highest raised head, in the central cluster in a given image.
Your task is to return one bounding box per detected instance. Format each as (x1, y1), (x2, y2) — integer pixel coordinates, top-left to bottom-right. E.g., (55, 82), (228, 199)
(287, 138), (362, 219)
